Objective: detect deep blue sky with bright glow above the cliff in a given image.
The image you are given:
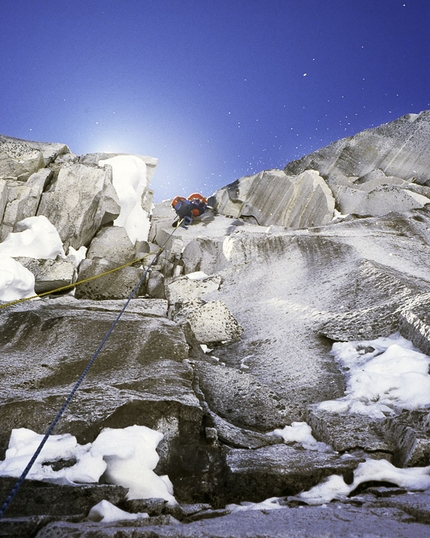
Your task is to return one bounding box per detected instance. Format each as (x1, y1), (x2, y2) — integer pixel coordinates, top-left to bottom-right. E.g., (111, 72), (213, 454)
(0, 0), (430, 201)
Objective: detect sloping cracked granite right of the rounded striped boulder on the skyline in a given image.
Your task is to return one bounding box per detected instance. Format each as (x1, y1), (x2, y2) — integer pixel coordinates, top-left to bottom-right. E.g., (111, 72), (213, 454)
(284, 110), (430, 215)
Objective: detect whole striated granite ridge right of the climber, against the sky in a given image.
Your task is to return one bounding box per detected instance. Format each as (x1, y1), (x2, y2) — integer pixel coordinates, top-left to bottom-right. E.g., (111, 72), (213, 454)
(212, 111), (430, 224)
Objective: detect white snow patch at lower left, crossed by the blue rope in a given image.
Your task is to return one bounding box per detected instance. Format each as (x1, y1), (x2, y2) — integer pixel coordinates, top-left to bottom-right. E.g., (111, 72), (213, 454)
(0, 426), (176, 504)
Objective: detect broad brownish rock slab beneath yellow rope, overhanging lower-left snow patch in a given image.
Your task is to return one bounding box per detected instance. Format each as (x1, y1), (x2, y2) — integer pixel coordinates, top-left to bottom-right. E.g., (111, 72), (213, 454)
(0, 298), (217, 501)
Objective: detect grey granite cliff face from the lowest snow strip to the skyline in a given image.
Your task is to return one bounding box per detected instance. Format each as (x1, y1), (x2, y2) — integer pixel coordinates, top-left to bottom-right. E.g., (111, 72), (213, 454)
(0, 112), (430, 536)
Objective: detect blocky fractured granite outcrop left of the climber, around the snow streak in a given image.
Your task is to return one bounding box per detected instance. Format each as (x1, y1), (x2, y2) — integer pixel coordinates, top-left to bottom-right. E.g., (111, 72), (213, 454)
(0, 135), (157, 299)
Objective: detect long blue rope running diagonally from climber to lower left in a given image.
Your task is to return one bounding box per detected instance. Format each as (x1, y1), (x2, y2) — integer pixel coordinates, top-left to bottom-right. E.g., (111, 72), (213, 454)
(0, 220), (182, 519)
